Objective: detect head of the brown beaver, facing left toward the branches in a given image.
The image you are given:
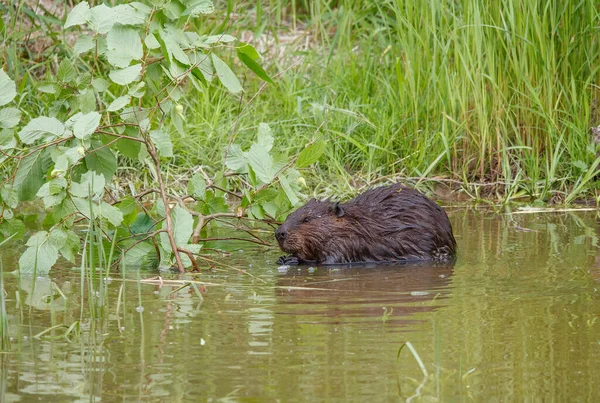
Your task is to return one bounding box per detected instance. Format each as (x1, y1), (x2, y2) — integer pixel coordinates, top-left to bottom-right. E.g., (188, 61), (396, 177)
(275, 199), (345, 261)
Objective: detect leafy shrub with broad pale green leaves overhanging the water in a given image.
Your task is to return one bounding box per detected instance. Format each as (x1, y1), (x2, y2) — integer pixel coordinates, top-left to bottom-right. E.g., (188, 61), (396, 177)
(0, 0), (324, 273)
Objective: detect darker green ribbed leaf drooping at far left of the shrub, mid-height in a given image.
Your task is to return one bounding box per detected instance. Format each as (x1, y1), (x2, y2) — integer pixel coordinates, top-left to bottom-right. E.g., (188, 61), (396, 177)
(14, 150), (52, 201)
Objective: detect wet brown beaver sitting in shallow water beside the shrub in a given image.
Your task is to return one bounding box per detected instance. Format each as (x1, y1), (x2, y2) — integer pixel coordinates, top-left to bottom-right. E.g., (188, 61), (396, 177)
(275, 184), (456, 264)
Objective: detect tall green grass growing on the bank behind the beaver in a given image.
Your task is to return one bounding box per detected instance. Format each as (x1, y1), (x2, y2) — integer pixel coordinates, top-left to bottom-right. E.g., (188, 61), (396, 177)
(180, 0), (600, 200)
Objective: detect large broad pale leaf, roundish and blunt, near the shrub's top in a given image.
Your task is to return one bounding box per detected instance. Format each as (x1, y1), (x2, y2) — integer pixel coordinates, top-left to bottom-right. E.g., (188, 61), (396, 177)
(106, 25), (144, 67)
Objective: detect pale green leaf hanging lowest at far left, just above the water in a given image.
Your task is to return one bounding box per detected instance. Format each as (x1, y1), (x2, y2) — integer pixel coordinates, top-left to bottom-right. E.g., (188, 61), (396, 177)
(19, 231), (59, 275)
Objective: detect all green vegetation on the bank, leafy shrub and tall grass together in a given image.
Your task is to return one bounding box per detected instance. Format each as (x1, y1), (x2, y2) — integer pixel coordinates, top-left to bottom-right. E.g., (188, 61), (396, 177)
(0, 0), (600, 272)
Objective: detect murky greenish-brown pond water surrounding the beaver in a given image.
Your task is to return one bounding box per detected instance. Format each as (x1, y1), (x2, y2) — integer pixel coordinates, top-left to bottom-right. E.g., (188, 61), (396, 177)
(0, 208), (600, 402)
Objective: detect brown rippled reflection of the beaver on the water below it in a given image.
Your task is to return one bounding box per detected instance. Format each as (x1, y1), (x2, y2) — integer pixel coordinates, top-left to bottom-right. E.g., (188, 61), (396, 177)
(276, 261), (454, 324)
